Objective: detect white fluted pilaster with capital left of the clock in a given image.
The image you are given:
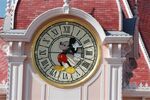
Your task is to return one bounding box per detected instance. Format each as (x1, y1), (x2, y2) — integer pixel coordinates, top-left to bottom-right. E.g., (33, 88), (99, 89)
(7, 42), (26, 100)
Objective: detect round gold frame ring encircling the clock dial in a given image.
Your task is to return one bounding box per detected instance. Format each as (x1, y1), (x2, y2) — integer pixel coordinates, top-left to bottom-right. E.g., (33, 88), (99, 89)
(31, 14), (102, 89)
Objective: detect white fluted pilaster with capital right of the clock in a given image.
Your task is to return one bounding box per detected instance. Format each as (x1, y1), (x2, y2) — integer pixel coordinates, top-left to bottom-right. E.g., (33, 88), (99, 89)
(105, 44), (125, 100)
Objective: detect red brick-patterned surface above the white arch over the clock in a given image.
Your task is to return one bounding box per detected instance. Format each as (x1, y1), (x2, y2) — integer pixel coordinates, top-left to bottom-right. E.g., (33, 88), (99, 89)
(15, 0), (119, 30)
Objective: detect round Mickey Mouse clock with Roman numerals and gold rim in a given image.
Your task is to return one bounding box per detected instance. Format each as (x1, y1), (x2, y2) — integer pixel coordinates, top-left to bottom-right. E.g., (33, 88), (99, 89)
(31, 15), (102, 88)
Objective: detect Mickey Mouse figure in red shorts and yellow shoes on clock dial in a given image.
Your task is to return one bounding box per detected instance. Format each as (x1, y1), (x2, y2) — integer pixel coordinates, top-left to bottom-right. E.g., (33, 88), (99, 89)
(56, 38), (78, 74)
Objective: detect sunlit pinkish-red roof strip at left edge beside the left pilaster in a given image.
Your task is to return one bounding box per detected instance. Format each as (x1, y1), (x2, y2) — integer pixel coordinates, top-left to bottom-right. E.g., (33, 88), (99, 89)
(0, 39), (8, 83)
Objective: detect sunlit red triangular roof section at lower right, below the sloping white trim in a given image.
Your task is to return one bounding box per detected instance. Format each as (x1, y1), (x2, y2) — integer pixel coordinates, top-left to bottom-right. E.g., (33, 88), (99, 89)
(130, 50), (150, 86)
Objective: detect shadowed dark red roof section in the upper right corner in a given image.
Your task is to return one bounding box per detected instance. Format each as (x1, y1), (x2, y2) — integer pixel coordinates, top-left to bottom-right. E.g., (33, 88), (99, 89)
(138, 0), (150, 55)
